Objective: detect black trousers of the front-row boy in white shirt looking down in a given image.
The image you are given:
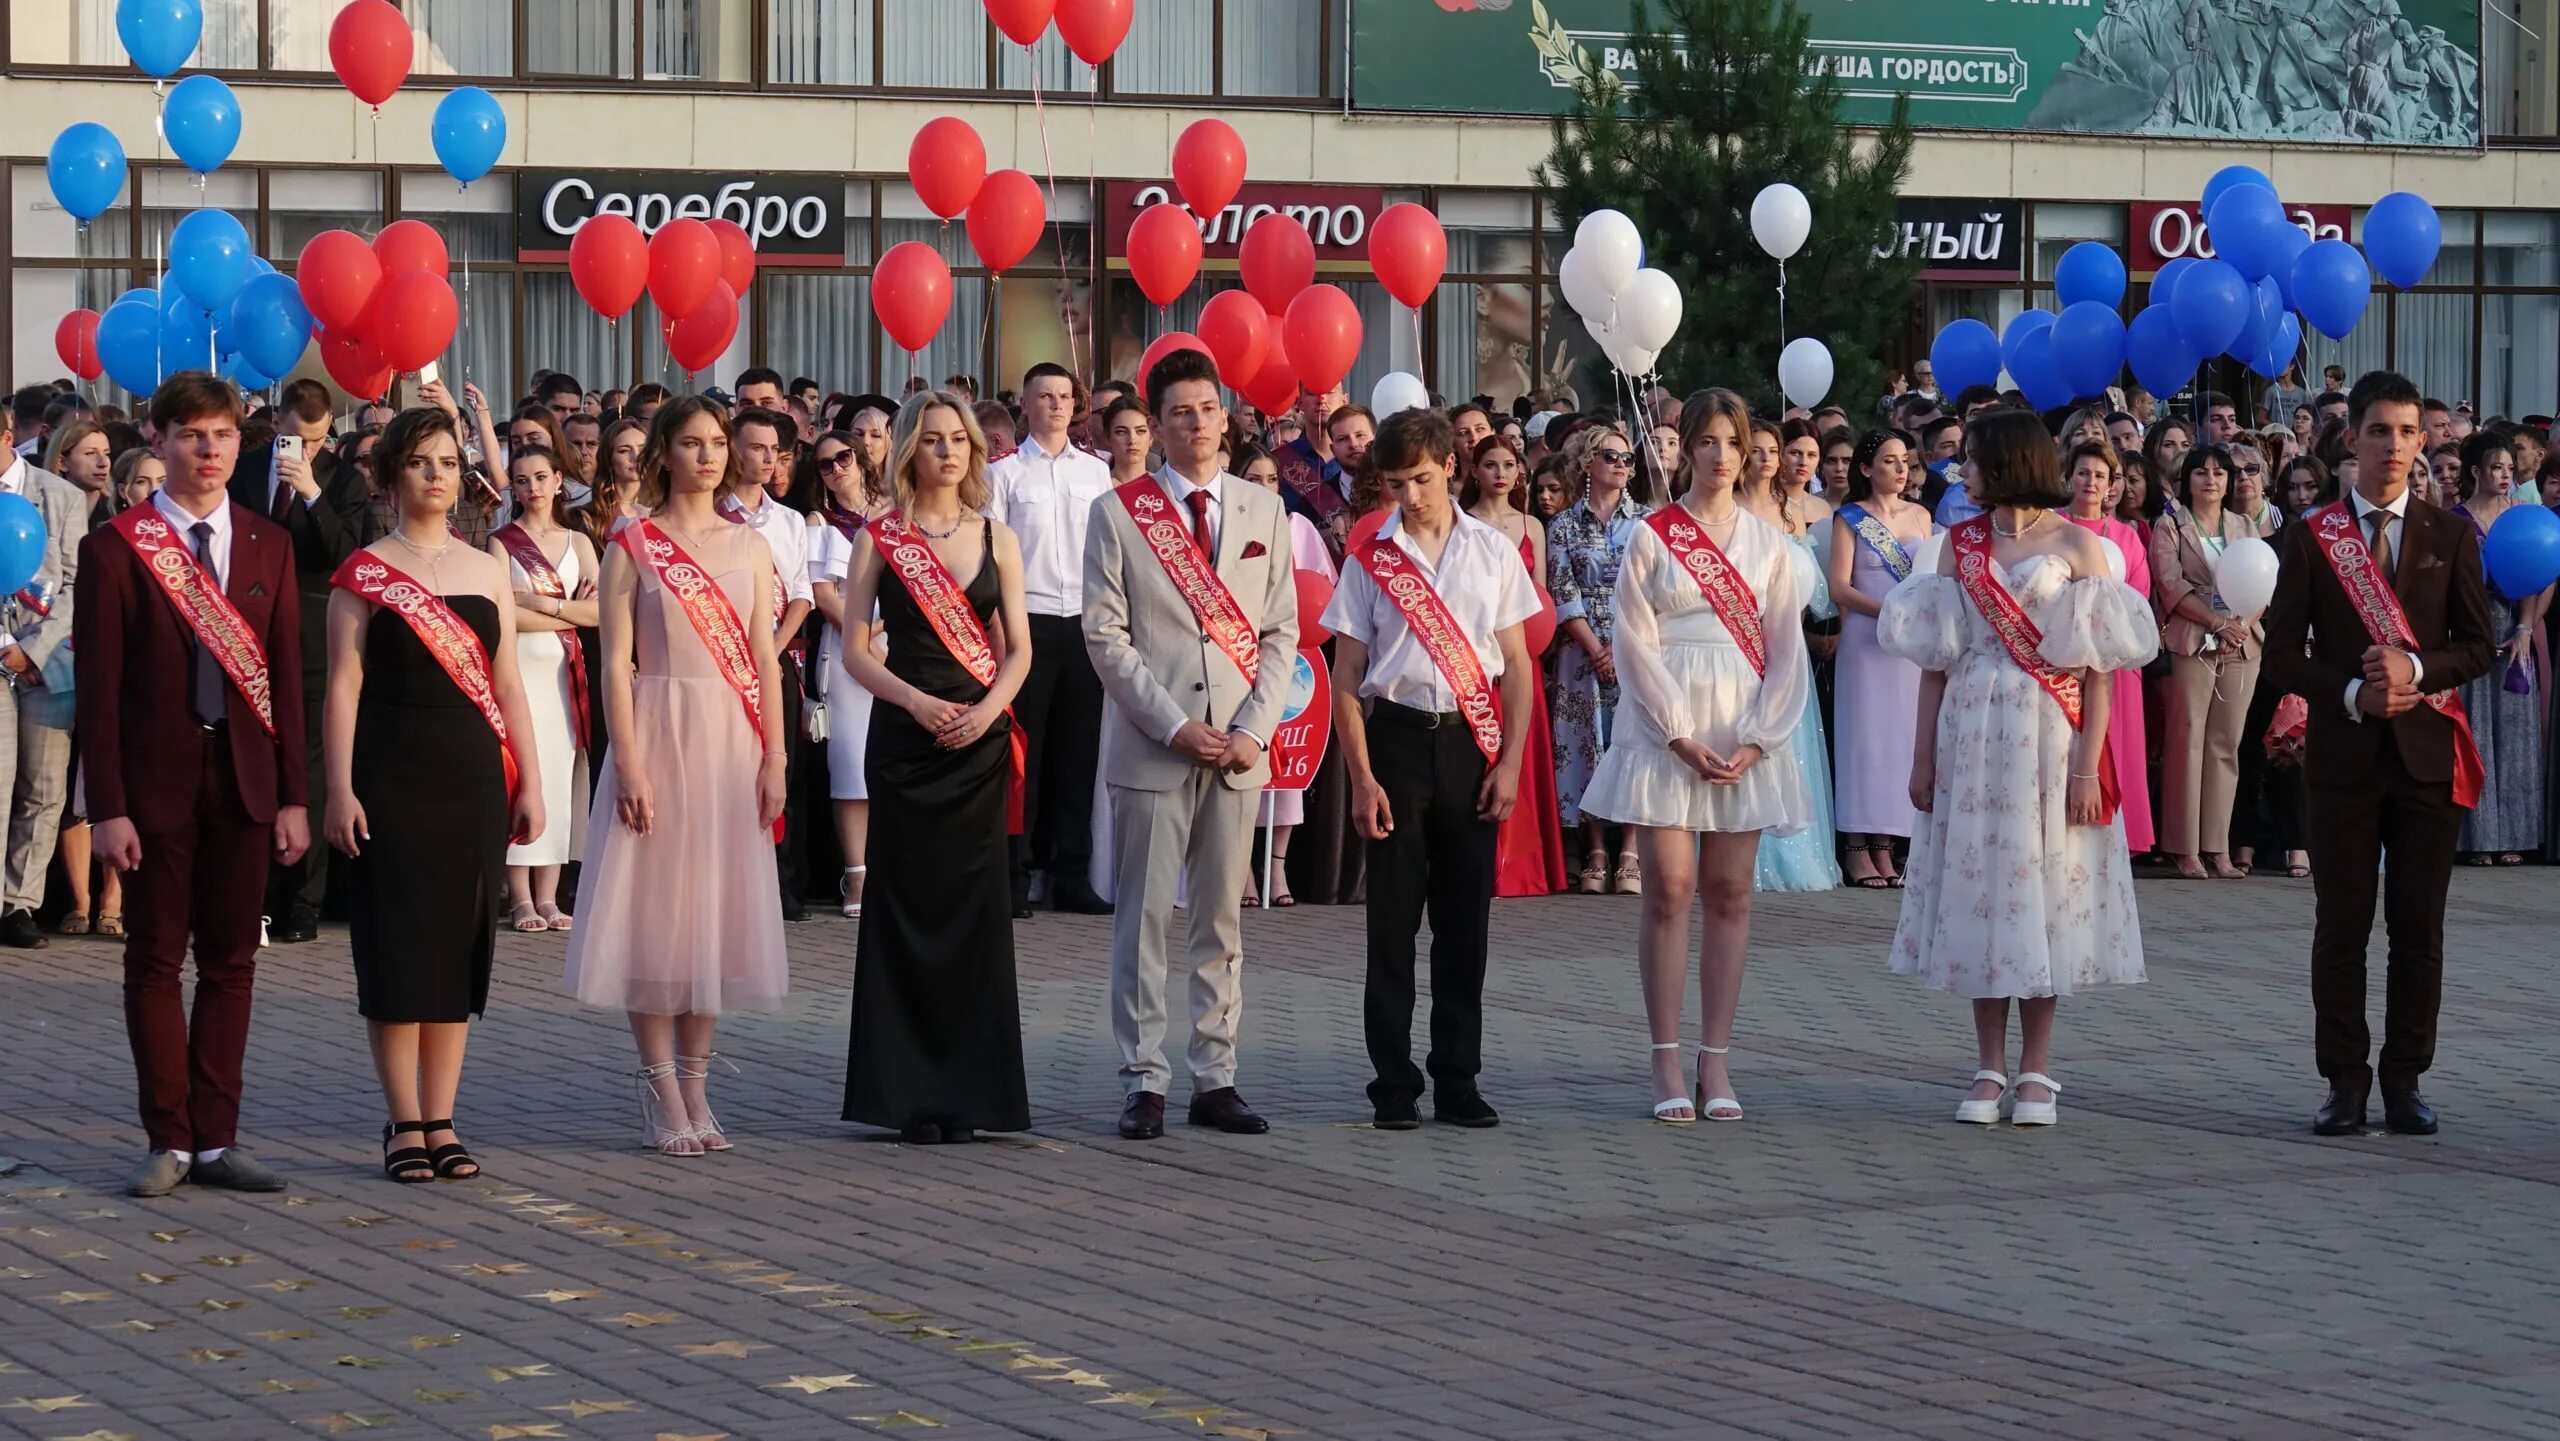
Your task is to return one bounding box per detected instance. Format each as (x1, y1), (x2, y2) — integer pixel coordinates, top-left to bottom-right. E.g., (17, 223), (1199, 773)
(1359, 701), (1498, 1103)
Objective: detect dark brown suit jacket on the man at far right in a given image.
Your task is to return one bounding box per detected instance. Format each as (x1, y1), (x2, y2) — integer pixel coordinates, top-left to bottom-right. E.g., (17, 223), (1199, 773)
(2266, 497), (2499, 786)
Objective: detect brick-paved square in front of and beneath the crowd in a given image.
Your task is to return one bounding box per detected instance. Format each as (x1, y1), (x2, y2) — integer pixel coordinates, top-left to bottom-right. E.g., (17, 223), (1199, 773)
(0, 870), (2560, 1441)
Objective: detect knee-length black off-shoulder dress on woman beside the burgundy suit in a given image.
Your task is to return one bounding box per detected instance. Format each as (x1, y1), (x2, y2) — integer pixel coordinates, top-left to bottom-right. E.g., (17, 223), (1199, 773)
(348, 596), (509, 1024)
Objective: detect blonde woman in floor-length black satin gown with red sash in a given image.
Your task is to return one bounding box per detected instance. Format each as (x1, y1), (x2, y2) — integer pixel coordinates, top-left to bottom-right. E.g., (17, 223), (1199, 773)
(845, 392), (1032, 1144)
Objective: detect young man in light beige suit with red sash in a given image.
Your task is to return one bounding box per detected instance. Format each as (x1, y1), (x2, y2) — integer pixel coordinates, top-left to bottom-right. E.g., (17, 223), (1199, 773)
(1085, 351), (1298, 1142)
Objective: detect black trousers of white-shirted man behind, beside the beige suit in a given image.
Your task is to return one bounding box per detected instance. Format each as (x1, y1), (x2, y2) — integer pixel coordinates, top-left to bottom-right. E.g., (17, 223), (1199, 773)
(1011, 614), (1103, 901)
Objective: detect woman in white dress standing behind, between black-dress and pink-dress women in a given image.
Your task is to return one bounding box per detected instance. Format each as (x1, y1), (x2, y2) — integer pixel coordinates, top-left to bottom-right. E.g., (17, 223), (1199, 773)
(489, 445), (596, 932)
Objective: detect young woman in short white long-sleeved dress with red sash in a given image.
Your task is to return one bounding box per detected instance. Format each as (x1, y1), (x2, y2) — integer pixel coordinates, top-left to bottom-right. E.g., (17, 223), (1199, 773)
(1582, 389), (1812, 1126)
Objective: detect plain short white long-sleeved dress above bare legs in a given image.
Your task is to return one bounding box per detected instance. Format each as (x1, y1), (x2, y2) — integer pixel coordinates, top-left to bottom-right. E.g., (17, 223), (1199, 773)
(1582, 512), (1812, 837)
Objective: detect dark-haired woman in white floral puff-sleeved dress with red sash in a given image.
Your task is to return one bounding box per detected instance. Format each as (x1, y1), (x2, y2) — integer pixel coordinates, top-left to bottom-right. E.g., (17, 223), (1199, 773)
(1876, 412), (2161, 1126)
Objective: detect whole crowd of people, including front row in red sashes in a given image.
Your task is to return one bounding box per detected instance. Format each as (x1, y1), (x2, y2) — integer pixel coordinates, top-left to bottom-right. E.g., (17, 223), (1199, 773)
(40, 337), (2560, 1193)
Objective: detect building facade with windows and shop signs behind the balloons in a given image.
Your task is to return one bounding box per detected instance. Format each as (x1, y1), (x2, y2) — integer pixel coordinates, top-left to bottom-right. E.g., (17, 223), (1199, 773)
(0, 0), (2560, 415)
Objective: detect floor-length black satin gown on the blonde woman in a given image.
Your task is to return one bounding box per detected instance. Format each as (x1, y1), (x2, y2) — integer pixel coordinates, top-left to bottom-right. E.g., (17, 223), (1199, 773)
(845, 525), (1032, 1131)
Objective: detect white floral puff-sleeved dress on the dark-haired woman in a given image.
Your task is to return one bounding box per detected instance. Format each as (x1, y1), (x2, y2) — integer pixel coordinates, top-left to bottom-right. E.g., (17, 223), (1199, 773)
(1876, 555), (2161, 1001)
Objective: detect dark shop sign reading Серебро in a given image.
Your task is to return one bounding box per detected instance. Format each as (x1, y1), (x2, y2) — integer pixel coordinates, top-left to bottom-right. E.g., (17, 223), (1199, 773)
(515, 169), (845, 266)
